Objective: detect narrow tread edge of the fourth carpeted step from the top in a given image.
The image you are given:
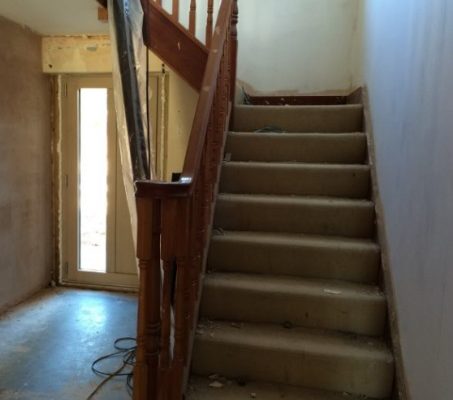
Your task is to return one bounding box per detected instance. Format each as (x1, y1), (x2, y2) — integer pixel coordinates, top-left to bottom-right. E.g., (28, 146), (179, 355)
(218, 193), (374, 208)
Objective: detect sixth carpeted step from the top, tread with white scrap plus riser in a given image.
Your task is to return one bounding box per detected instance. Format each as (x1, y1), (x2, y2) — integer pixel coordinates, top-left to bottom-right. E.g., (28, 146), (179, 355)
(201, 273), (387, 336)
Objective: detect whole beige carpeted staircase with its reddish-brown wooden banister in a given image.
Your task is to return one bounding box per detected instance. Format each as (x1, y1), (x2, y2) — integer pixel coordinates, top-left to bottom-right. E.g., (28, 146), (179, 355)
(102, 0), (395, 400)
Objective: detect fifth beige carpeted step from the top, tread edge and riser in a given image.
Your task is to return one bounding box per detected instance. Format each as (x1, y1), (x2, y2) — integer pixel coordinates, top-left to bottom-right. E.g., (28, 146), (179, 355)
(208, 231), (380, 284)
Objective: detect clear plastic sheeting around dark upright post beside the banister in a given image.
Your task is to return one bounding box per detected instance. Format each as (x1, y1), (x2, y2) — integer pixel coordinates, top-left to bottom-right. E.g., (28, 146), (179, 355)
(108, 0), (155, 252)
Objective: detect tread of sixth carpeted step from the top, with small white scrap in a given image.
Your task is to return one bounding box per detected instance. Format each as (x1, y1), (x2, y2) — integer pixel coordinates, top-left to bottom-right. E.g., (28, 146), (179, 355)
(205, 272), (385, 301)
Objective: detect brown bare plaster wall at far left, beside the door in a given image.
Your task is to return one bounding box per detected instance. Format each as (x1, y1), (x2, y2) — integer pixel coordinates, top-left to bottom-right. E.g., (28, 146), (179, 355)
(0, 17), (52, 310)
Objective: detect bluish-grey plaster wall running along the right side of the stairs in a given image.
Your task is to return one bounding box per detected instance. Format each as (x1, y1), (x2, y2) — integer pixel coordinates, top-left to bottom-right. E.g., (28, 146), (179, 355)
(364, 0), (453, 400)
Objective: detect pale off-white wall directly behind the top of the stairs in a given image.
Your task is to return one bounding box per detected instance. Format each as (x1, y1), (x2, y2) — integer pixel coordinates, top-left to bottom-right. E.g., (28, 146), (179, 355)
(238, 0), (363, 93)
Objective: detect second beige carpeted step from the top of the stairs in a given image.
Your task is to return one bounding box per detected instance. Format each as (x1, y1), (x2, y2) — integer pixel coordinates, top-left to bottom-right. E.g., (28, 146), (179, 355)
(225, 132), (367, 164)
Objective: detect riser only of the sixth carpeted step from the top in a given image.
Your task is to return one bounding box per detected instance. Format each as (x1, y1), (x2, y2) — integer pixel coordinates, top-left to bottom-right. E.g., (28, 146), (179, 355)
(201, 278), (386, 336)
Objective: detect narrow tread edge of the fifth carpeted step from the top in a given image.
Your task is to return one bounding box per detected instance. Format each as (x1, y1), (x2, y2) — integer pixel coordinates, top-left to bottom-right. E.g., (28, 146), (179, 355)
(212, 229), (380, 251)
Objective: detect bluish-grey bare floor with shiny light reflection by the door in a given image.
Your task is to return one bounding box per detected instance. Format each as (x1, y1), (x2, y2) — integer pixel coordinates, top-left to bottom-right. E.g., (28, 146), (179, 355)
(0, 288), (137, 400)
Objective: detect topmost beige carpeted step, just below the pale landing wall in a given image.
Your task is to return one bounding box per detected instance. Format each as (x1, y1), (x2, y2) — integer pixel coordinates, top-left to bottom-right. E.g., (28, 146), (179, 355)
(233, 104), (363, 133)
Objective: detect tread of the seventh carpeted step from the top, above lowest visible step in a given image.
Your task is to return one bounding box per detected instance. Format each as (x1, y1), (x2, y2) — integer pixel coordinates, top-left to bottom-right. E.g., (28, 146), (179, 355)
(196, 320), (393, 360)
